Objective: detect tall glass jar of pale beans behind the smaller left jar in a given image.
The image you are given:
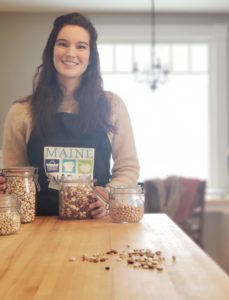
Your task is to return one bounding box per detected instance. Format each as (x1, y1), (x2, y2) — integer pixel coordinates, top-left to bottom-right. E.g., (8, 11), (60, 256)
(1, 167), (38, 223)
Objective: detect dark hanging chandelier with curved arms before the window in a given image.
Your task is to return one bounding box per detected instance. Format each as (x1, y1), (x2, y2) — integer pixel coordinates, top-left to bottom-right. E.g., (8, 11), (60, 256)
(133, 0), (169, 90)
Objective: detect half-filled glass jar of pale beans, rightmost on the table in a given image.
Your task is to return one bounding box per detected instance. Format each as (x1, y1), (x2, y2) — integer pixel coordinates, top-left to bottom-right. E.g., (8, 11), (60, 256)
(109, 185), (144, 223)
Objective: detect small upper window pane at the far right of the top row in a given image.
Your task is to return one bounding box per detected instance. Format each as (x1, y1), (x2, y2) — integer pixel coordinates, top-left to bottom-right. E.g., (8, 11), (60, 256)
(191, 44), (208, 72)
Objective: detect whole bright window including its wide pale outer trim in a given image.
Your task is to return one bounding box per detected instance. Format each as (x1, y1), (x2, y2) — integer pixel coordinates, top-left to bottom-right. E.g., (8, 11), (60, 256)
(99, 26), (229, 191)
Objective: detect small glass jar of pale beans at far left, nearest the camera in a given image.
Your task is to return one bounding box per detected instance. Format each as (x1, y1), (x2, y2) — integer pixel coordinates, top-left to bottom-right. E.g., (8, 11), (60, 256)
(0, 194), (21, 235)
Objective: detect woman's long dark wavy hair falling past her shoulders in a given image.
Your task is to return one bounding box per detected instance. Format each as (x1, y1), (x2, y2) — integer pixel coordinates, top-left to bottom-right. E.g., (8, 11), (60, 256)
(30, 13), (115, 136)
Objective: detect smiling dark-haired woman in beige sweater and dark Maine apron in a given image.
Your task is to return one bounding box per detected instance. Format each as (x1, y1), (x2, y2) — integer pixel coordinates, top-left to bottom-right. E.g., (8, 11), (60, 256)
(0, 13), (139, 218)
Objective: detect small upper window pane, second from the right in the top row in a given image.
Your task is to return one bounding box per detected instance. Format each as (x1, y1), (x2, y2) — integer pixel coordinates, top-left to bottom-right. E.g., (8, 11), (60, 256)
(172, 45), (189, 71)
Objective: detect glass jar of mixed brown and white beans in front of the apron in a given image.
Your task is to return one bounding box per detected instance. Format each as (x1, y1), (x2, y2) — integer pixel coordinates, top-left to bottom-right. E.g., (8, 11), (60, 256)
(59, 176), (95, 220)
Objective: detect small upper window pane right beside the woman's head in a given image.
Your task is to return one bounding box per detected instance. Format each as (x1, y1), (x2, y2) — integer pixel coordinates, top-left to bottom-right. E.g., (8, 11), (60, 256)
(98, 44), (114, 72)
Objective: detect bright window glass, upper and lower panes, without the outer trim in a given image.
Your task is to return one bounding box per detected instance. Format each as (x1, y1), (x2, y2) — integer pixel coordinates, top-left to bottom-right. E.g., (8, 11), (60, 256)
(98, 44), (209, 180)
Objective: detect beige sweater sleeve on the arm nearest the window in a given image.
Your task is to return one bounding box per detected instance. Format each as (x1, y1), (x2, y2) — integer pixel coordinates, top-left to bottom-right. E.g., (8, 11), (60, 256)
(105, 93), (140, 186)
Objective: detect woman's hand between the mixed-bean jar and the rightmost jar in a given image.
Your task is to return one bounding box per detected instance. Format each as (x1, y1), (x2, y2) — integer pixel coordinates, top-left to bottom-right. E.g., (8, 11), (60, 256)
(90, 186), (109, 219)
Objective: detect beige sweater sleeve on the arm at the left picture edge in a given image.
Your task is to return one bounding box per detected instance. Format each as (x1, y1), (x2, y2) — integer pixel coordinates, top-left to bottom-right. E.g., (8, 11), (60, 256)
(2, 102), (31, 168)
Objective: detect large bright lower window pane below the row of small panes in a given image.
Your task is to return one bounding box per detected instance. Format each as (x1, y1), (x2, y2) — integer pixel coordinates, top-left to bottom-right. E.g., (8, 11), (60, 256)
(104, 74), (209, 180)
